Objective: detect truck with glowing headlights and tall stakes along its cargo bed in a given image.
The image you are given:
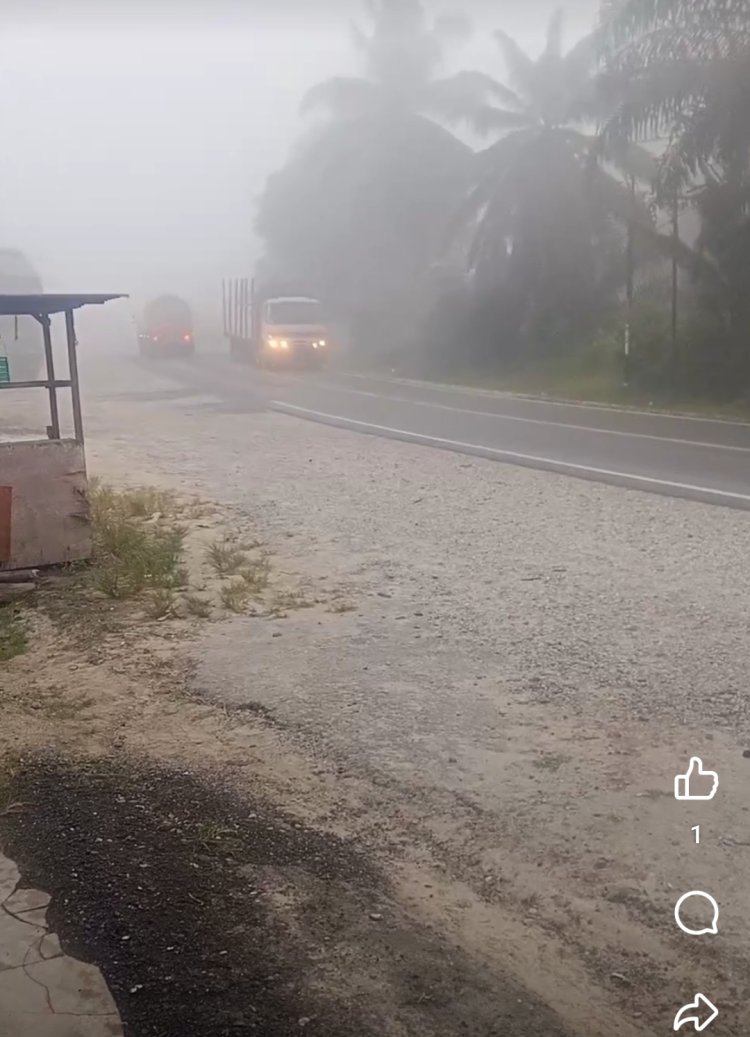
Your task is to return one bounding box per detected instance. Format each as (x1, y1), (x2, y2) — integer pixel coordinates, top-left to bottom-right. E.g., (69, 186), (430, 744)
(222, 278), (330, 368)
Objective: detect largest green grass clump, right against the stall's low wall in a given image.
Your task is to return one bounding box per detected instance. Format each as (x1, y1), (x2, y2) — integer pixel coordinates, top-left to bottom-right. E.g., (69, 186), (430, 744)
(89, 484), (188, 598)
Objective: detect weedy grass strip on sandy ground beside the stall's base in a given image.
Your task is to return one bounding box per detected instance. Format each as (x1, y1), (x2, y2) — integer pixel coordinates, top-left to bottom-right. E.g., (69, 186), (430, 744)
(0, 479), (342, 664)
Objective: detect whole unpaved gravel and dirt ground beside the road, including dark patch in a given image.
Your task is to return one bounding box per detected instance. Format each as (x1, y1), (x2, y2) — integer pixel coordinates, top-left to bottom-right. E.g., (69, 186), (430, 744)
(0, 352), (750, 1037)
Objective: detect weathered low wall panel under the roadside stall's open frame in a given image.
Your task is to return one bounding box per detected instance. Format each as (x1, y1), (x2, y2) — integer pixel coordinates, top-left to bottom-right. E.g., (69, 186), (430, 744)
(0, 440), (91, 570)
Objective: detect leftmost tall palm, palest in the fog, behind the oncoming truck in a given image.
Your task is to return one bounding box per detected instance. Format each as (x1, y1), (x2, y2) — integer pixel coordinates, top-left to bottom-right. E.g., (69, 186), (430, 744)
(256, 0), (471, 356)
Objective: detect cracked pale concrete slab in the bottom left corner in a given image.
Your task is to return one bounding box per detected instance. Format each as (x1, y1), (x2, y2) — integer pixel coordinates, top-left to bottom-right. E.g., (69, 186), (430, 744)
(0, 853), (122, 1037)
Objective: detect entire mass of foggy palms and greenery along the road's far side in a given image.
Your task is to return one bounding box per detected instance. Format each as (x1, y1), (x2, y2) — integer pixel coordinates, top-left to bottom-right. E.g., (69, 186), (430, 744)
(256, 0), (750, 414)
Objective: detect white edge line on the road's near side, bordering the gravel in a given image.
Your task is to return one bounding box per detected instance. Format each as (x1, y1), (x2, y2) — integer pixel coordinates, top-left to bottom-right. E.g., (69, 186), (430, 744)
(271, 400), (750, 504)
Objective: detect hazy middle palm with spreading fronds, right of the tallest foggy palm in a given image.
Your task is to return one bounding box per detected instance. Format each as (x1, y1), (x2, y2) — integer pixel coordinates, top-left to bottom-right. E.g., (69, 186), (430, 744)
(435, 13), (654, 356)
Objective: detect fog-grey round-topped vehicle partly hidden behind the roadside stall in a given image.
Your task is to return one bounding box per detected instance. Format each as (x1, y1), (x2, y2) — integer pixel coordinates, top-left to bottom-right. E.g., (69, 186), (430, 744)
(0, 249), (45, 382)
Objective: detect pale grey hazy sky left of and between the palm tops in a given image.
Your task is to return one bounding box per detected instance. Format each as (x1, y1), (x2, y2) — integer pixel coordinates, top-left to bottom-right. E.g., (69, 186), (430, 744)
(0, 0), (598, 327)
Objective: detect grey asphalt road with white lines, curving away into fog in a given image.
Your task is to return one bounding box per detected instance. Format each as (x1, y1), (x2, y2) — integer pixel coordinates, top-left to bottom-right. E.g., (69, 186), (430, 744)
(132, 354), (750, 509)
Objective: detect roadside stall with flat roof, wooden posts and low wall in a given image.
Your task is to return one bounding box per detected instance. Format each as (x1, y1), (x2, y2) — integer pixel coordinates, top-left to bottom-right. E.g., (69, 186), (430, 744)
(0, 292), (127, 572)
